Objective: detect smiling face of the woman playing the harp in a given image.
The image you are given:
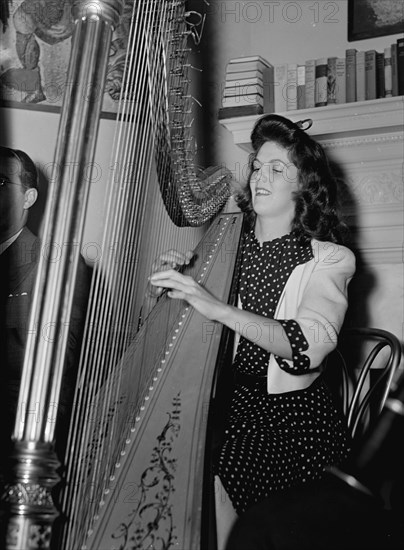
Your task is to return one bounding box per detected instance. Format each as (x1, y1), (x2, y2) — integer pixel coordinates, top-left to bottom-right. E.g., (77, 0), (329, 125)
(250, 141), (298, 222)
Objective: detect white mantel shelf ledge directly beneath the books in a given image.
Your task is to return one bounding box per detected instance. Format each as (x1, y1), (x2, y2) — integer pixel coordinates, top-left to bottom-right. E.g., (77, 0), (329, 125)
(219, 96), (404, 152)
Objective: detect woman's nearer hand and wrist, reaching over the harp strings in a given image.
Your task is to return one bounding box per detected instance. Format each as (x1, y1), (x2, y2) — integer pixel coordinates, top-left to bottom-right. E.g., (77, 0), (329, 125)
(150, 269), (227, 321)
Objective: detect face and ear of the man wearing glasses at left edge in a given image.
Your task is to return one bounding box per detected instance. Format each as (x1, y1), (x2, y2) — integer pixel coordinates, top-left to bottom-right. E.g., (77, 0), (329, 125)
(0, 157), (30, 242)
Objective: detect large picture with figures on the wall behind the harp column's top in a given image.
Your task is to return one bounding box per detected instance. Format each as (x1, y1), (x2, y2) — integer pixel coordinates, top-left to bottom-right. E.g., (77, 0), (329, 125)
(0, 0), (133, 118)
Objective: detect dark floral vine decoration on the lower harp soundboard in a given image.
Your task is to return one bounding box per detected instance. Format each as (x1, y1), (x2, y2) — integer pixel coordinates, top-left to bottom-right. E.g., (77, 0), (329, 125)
(111, 394), (181, 550)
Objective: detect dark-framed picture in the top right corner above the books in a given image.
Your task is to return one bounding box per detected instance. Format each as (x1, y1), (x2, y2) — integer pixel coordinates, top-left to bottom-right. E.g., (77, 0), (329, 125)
(348, 0), (404, 42)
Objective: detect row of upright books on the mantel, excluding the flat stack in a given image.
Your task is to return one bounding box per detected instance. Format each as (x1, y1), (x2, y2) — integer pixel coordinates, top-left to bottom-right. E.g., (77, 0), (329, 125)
(274, 38), (404, 112)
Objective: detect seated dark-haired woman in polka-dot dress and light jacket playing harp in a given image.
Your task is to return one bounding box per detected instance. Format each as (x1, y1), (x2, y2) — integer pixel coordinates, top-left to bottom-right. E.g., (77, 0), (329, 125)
(151, 115), (355, 547)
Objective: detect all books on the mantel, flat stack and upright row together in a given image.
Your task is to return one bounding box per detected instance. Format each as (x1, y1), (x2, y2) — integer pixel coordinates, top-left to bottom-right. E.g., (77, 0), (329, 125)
(219, 38), (404, 118)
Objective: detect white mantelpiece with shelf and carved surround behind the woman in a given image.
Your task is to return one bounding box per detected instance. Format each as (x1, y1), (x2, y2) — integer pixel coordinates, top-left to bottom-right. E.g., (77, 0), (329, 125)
(220, 96), (404, 264)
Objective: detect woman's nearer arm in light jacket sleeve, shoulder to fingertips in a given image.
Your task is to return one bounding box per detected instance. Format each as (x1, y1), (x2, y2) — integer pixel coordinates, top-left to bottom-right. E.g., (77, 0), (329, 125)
(150, 243), (355, 366)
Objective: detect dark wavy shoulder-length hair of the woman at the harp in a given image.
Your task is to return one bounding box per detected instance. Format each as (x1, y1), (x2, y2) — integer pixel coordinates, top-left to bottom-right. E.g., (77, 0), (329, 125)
(236, 115), (348, 243)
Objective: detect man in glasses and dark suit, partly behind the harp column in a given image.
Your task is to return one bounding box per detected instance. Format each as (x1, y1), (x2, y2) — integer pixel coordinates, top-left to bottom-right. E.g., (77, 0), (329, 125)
(0, 146), (90, 458)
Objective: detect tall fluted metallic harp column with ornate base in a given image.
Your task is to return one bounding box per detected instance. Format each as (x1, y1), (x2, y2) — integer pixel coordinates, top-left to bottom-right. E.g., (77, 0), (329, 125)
(1, 0), (123, 550)
